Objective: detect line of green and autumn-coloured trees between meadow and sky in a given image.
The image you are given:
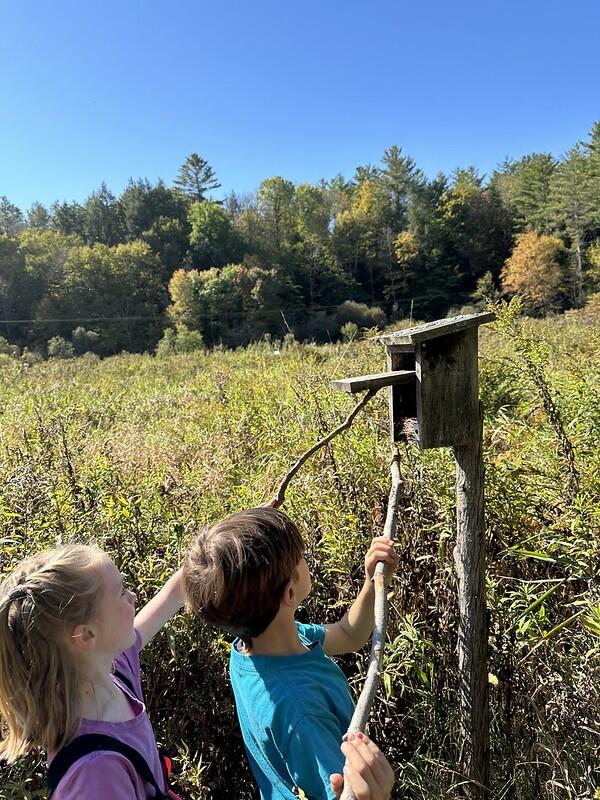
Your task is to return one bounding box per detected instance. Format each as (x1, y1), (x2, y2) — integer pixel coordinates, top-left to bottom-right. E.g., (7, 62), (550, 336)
(0, 122), (600, 355)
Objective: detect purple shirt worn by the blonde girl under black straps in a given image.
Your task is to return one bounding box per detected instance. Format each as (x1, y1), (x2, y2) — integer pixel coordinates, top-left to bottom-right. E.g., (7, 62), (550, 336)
(48, 631), (166, 800)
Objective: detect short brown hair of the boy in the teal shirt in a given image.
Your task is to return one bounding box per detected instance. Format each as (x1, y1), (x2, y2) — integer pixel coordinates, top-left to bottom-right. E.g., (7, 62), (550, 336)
(183, 508), (304, 645)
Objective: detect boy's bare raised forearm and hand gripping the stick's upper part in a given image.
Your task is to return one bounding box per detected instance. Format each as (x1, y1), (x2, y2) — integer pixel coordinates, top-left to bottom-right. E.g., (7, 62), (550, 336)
(323, 536), (398, 656)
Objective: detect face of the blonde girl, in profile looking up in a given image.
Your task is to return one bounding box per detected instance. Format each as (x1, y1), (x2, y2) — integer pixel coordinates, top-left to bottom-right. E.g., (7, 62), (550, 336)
(91, 558), (135, 657)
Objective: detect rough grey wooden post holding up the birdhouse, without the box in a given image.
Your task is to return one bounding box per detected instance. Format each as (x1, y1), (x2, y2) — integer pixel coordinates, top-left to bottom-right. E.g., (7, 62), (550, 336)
(453, 408), (489, 800)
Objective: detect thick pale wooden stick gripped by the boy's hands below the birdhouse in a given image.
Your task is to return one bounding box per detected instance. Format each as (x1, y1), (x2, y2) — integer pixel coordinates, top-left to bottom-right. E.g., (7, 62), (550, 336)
(340, 447), (401, 800)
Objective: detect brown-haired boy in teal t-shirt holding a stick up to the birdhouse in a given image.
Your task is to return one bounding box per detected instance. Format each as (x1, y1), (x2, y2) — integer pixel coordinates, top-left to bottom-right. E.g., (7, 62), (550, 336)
(183, 507), (398, 800)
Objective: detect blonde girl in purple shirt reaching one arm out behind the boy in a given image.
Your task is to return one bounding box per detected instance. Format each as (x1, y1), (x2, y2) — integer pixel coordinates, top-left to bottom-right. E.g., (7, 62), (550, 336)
(0, 544), (183, 800)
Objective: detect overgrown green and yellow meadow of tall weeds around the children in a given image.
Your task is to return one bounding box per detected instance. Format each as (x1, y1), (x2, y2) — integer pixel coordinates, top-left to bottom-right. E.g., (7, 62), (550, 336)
(0, 309), (600, 800)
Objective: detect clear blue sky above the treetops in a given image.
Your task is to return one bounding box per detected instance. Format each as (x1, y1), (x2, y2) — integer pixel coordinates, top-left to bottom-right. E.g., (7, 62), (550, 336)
(0, 0), (600, 209)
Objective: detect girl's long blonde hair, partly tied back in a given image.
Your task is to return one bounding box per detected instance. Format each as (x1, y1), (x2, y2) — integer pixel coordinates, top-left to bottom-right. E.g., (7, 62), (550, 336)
(0, 544), (107, 761)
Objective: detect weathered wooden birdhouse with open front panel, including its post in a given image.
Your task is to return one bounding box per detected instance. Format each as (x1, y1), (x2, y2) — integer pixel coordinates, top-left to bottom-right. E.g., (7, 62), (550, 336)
(334, 313), (494, 800)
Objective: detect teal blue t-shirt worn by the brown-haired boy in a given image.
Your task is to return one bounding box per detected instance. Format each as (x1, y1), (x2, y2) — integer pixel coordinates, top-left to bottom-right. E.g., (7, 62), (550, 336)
(229, 622), (354, 800)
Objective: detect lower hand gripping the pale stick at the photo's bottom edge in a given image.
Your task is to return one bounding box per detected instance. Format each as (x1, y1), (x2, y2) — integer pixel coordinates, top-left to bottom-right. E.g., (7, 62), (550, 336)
(330, 731), (395, 800)
